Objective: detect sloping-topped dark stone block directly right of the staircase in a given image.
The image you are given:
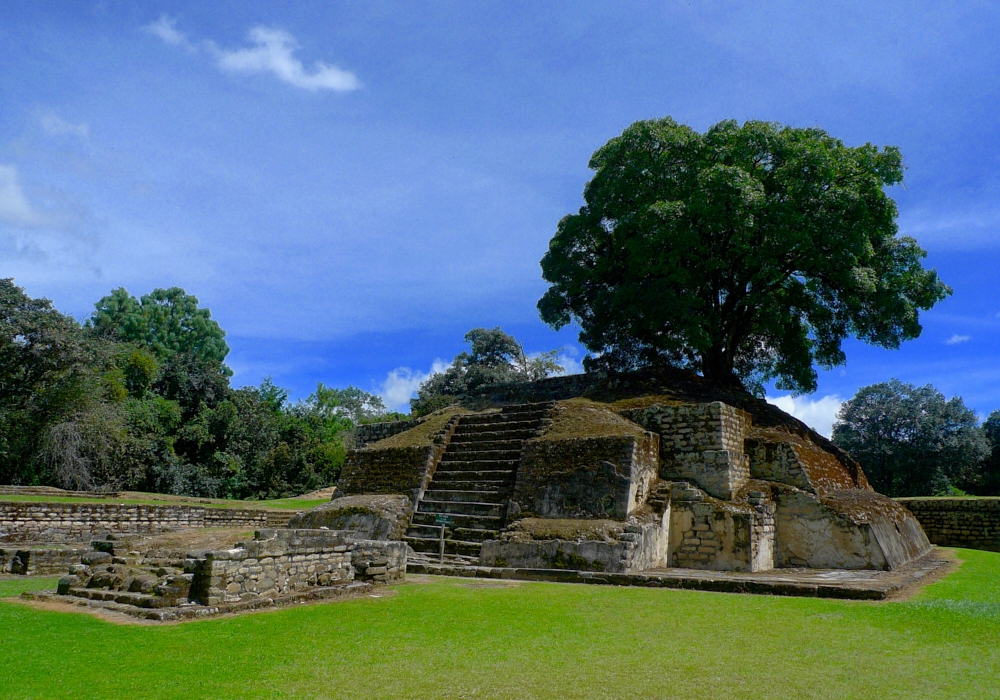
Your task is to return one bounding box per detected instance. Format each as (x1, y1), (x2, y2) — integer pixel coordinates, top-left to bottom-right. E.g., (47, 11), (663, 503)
(510, 433), (659, 520)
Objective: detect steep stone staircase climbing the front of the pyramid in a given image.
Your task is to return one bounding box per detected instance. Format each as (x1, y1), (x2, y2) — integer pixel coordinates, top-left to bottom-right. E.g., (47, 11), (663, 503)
(404, 403), (553, 564)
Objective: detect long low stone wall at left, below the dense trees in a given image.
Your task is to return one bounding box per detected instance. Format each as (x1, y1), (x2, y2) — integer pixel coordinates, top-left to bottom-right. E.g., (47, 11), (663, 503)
(0, 502), (292, 542)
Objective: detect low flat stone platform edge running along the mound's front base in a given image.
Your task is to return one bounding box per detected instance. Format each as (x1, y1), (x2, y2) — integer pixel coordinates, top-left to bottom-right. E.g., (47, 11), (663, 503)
(407, 549), (953, 600)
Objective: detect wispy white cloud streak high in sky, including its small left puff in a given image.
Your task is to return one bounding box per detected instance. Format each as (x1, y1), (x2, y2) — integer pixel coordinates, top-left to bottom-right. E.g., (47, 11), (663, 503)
(142, 15), (361, 92)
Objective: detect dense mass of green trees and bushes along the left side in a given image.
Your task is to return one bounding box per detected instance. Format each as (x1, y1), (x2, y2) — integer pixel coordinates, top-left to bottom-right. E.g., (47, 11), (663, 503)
(0, 280), (398, 498)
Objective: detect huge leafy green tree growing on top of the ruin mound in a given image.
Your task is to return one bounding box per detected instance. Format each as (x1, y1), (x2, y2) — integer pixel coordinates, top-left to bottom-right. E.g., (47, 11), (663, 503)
(538, 118), (950, 392)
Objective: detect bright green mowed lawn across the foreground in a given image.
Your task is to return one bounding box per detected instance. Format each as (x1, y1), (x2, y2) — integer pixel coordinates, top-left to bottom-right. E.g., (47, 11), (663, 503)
(0, 550), (1000, 700)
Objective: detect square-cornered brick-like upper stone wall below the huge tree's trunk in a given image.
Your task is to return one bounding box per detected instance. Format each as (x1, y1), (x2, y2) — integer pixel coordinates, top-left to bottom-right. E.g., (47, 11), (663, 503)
(622, 401), (751, 500)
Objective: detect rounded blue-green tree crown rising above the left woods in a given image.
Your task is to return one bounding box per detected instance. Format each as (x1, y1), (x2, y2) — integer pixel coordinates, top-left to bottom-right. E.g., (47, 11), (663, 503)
(87, 287), (229, 365)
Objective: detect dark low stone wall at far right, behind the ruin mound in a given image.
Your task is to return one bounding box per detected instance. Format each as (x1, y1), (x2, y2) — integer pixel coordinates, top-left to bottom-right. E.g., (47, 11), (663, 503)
(896, 498), (1000, 552)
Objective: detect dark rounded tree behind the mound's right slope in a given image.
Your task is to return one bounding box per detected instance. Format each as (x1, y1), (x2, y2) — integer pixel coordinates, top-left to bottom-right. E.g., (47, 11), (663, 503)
(833, 379), (990, 496)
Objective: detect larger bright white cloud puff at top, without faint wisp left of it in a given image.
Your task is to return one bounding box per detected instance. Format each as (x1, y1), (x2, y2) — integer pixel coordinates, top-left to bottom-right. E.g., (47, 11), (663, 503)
(211, 27), (361, 92)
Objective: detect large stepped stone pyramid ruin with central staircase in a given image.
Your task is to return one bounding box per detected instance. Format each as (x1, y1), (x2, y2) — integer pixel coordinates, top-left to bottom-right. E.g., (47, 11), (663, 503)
(334, 370), (930, 573)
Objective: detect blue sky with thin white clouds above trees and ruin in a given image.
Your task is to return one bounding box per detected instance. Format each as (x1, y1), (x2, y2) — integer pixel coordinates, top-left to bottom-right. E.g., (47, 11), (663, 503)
(0, 0), (1000, 434)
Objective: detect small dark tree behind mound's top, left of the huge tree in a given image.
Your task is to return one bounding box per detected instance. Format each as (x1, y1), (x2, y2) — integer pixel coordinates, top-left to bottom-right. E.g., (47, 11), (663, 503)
(410, 326), (563, 415)
